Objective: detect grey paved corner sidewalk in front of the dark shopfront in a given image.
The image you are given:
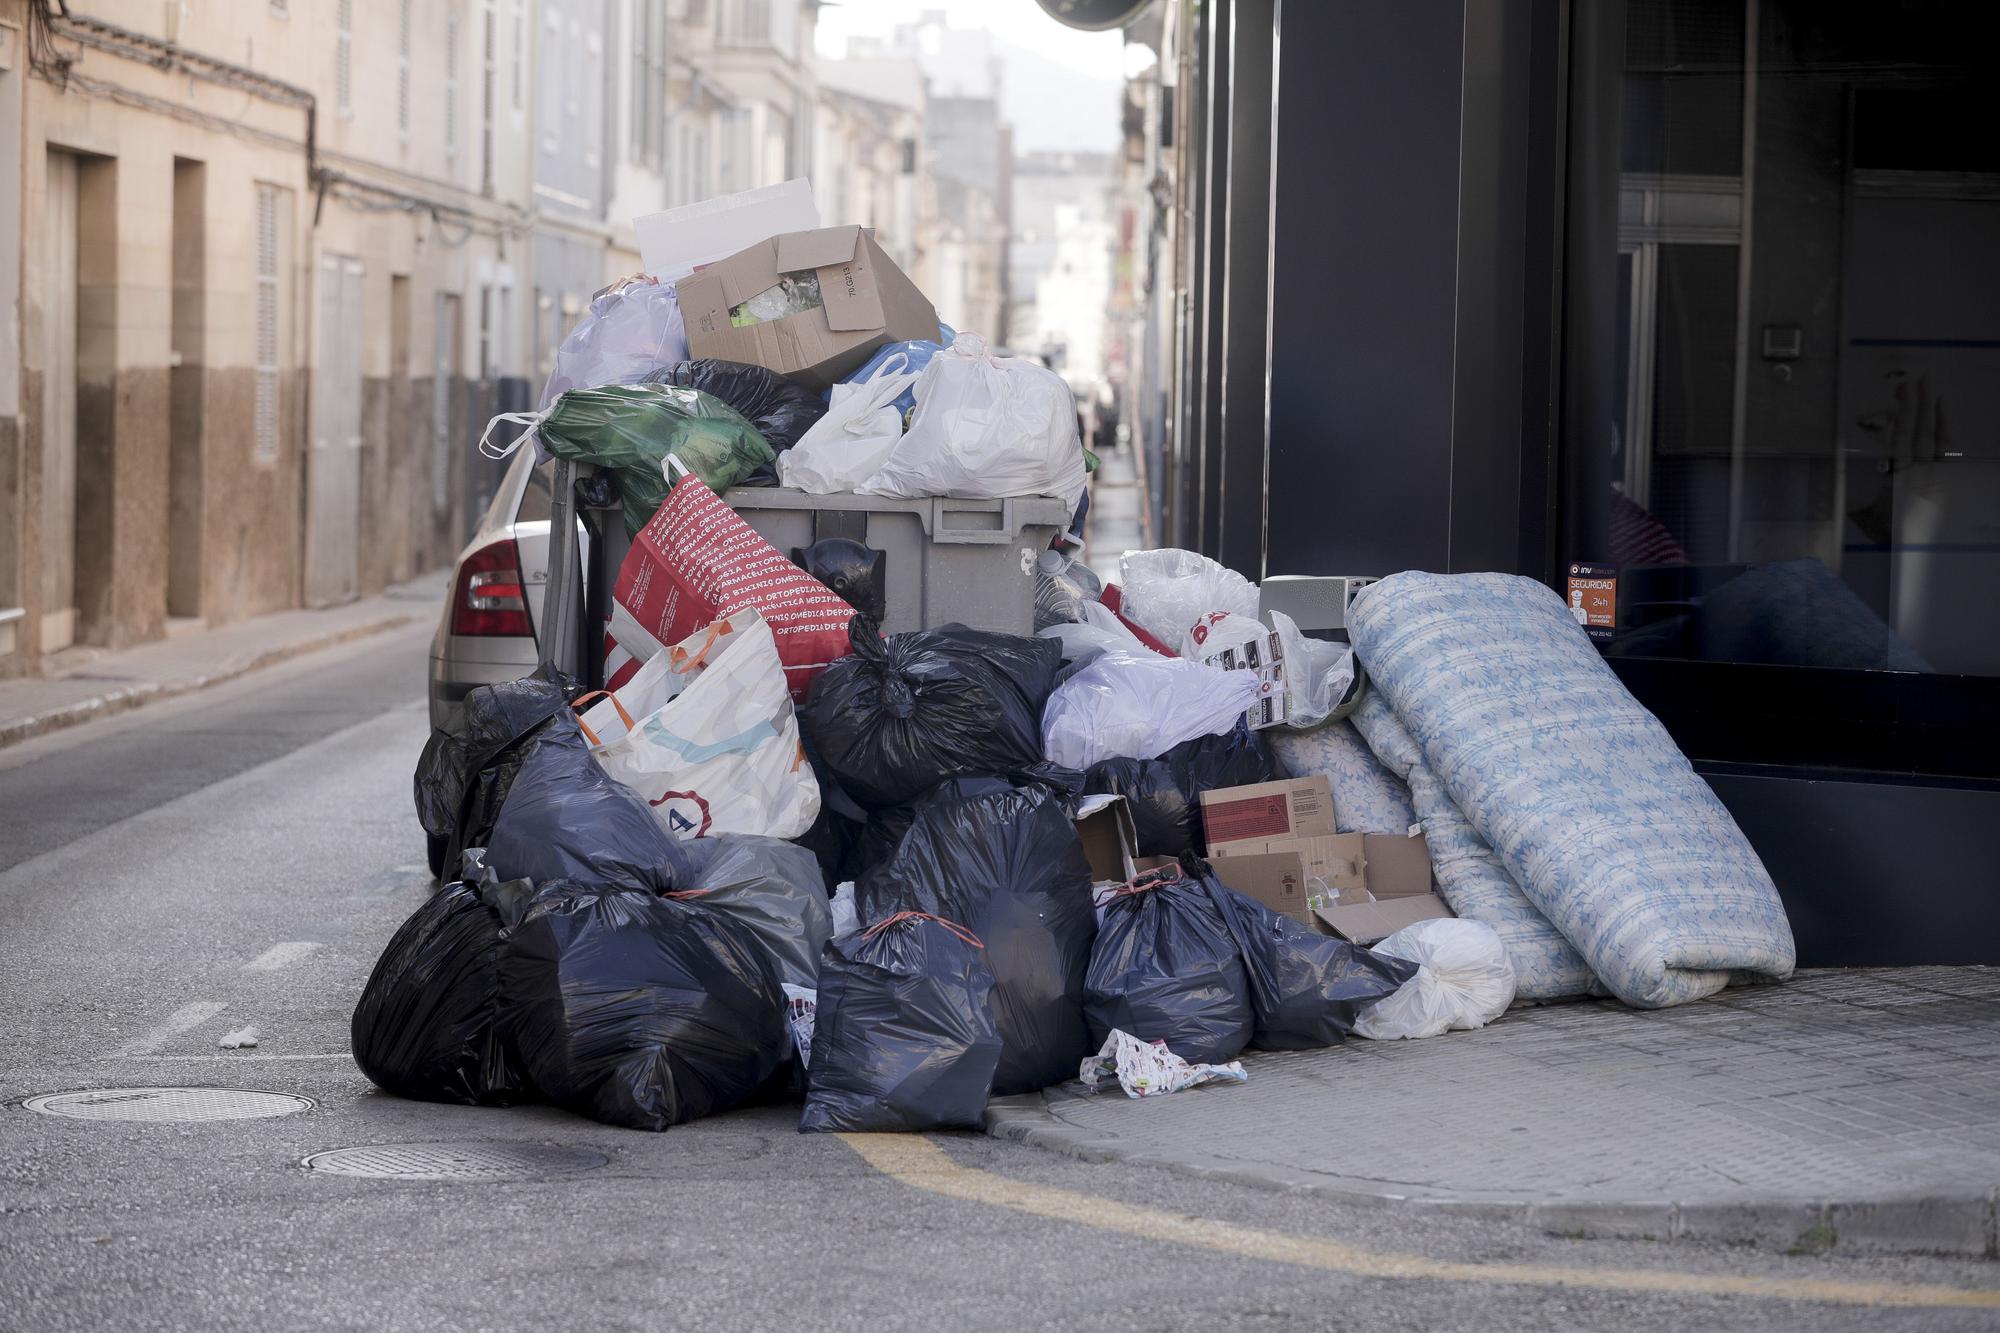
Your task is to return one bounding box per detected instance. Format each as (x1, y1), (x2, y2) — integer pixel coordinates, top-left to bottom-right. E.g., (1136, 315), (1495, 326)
(988, 967), (2000, 1257)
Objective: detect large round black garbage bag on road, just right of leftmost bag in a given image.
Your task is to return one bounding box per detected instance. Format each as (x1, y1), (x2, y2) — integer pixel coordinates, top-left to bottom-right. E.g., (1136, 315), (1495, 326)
(500, 885), (792, 1131)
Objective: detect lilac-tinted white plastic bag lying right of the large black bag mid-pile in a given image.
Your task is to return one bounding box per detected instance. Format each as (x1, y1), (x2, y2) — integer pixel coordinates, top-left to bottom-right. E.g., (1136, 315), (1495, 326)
(1042, 650), (1260, 771)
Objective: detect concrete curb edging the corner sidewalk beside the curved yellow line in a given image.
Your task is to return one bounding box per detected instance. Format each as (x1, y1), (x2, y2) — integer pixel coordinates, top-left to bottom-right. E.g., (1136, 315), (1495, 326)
(986, 1093), (2000, 1259)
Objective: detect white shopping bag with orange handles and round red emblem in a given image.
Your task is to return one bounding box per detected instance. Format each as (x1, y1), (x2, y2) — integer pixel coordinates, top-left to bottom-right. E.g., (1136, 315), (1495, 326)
(578, 608), (820, 839)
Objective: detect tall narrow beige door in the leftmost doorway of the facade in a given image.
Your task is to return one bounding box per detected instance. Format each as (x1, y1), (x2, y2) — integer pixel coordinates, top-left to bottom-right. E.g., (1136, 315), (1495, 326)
(42, 150), (78, 652)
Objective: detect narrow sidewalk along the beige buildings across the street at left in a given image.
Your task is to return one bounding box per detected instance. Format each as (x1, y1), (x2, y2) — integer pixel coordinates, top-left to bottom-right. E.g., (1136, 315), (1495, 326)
(0, 570), (450, 747)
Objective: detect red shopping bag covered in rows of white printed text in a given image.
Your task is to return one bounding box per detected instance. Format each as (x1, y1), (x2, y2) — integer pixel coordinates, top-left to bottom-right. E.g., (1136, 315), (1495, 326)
(604, 476), (854, 703)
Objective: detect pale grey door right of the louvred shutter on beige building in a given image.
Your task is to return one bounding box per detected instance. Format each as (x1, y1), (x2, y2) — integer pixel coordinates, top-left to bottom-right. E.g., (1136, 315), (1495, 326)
(306, 254), (364, 606)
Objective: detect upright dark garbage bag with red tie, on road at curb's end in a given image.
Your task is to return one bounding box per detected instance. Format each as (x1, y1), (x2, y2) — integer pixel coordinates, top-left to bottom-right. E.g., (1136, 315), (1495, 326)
(798, 913), (1000, 1133)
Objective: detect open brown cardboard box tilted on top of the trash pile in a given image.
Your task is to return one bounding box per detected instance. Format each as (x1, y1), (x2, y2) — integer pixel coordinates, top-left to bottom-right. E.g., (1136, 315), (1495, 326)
(676, 226), (938, 388)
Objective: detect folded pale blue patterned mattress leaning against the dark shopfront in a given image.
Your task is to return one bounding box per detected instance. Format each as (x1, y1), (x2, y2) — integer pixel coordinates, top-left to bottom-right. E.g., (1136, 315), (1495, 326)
(1334, 572), (1794, 1009)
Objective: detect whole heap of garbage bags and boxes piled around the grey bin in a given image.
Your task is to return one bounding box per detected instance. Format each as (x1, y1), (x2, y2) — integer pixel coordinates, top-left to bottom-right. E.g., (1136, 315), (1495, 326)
(354, 182), (1788, 1131)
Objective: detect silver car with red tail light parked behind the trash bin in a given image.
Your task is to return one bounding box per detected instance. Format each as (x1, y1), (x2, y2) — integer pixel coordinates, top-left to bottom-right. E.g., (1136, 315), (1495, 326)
(430, 448), (582, 731)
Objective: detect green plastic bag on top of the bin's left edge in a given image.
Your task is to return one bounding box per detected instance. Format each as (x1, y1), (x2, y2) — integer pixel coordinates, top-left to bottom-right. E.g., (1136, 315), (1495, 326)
(534, 384), (778, 536)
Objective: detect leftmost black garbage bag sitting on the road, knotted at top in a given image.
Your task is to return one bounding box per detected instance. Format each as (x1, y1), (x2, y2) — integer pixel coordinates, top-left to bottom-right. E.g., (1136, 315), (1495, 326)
(352, 857), (534, 1107)
